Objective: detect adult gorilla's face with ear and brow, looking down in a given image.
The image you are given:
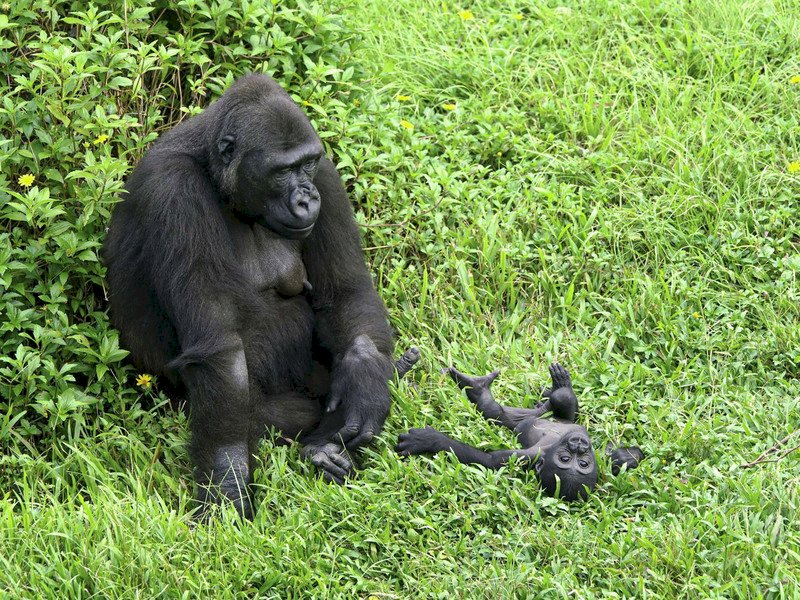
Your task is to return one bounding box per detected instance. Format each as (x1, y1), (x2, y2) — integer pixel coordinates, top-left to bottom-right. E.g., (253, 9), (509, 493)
(217, 98), (323, 239)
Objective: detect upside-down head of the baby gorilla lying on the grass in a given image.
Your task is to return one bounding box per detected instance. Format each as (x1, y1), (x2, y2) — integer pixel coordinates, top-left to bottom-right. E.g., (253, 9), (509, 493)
(537, 432), (597, 500)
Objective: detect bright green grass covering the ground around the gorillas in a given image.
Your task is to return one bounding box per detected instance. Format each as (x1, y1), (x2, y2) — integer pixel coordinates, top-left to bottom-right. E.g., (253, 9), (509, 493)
(0, 0), (800, 598)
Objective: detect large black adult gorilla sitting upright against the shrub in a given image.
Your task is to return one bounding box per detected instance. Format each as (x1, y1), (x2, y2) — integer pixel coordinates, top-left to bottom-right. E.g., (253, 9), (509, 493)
(103, 75), (392, 517)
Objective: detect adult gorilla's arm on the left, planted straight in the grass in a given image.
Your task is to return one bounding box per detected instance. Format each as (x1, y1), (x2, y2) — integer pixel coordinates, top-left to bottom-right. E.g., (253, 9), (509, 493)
(131, 153), (252, 517)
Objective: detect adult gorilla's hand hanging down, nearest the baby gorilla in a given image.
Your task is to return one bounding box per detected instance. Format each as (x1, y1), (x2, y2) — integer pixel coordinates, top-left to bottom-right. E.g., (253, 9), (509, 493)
(325, 335), (393, 450)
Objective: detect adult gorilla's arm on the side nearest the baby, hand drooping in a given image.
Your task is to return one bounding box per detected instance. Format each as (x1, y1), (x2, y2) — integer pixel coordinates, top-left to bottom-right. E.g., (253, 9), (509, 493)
(303, 158), (393, 448)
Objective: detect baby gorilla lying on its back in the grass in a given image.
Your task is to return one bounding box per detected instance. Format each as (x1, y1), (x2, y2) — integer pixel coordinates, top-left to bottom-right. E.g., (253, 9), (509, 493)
(397, 363), (641, 501)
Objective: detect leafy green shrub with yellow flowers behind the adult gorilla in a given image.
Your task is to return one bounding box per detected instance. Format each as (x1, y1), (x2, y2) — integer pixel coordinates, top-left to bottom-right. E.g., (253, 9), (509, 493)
(0, 0), (360, 458)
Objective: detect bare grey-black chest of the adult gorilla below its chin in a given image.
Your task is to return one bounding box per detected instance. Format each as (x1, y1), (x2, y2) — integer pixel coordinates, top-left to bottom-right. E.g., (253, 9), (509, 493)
(232, 225), (306, 297)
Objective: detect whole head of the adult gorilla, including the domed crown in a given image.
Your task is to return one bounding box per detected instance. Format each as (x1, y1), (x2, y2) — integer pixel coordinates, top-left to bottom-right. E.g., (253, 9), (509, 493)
(209, 75), (323, 239)
